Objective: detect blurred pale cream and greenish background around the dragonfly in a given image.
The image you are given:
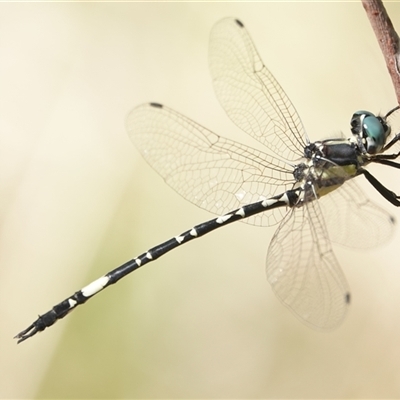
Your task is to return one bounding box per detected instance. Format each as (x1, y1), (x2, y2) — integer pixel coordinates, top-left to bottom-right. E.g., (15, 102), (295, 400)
(0, 2), (400, 398)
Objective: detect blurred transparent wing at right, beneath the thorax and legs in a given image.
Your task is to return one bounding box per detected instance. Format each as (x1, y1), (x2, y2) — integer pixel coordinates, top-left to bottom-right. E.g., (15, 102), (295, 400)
(319, 180), (395, 249)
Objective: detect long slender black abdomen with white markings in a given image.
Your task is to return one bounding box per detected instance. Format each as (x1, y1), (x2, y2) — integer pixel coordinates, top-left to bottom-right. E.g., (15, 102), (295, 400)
(15, 189), (302, 343)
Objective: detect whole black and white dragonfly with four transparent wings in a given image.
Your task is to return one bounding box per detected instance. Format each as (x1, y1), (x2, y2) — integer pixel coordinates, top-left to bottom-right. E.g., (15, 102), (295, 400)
(15, 18), (400, 343)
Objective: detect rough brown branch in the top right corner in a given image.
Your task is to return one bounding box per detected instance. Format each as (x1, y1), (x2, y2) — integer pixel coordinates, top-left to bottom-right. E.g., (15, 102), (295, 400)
(361, 0), (400, 104)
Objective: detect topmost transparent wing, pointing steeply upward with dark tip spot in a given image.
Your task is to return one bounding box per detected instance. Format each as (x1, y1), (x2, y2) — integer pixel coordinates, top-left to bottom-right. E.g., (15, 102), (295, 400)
(209, 18), (305, 161)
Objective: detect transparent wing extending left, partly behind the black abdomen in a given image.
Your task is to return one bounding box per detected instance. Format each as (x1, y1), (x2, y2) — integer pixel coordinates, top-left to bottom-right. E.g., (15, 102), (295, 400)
(127, 104), (294, 226)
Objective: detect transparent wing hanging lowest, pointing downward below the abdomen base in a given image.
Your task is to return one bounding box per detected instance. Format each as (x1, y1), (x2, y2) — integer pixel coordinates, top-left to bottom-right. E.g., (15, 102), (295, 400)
(266, 193), (350, 330)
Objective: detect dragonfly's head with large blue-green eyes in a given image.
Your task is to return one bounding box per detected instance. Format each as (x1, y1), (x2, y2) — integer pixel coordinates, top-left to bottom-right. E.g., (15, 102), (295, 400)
(350, 111), (390, 154)
